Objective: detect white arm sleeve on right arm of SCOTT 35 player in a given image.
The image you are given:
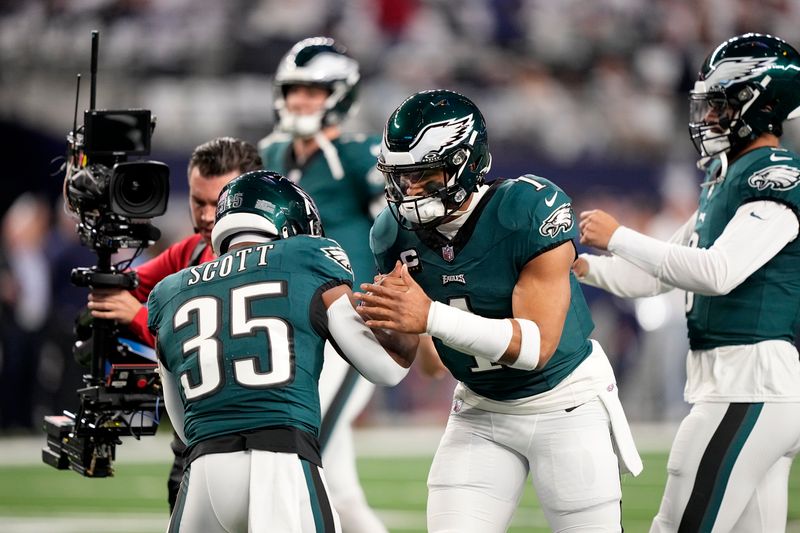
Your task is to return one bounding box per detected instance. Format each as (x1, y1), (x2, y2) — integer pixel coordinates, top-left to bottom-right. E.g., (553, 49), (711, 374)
(328, 294), (408, 386)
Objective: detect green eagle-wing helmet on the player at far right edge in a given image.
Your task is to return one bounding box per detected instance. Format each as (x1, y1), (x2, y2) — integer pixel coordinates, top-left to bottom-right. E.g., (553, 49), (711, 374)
(689, 33), (800, 158)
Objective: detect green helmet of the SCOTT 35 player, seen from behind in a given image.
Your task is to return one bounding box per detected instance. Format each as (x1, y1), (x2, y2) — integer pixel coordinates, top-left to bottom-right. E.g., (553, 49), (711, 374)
(216, 170), (324, 255)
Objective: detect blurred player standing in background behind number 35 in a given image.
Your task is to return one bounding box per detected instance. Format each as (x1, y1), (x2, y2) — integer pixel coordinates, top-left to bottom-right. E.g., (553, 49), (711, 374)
(258, 37), (386, 533)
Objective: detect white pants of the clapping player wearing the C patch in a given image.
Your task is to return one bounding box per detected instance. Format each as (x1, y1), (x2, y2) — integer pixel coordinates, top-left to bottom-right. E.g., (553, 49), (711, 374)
(428, 398), (621, 533)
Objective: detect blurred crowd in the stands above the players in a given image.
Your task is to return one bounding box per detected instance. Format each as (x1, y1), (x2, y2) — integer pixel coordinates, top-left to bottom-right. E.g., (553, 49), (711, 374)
(0, 0), (800, 162)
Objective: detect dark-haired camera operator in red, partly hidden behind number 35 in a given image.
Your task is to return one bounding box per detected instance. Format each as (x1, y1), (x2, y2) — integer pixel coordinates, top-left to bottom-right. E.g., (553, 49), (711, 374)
(88, 137), (261, 510)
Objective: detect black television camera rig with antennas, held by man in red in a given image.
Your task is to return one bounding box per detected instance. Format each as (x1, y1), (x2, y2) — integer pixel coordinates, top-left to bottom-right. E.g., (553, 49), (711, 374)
(42, 31), (169, 477)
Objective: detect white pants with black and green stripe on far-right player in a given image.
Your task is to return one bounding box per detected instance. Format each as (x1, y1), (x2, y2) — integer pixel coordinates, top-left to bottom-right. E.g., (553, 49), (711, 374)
(650, 403), (800, 533)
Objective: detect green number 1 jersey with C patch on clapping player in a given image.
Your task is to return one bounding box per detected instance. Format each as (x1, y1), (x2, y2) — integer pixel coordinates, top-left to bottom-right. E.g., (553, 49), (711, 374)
(371, 176), (594, 400)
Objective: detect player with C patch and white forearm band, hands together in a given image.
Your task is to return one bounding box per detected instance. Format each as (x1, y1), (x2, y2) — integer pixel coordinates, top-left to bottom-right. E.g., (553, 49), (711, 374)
(356, 90), (641, 533)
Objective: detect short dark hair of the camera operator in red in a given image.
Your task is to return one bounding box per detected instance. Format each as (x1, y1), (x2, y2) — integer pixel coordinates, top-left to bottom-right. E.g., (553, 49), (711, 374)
(187, 137), (262, 177)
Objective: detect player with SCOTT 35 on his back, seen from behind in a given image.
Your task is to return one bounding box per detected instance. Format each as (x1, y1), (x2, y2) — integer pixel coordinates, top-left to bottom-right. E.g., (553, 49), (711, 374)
(148, 170), (417, 533)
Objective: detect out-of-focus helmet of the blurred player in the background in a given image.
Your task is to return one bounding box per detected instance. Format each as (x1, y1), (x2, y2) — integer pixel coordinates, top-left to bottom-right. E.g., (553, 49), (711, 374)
(273, 37), (361, 137)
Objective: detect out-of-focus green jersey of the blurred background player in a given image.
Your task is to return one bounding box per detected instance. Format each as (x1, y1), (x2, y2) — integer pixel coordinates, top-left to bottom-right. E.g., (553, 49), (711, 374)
(259, 134), (384, 286)
